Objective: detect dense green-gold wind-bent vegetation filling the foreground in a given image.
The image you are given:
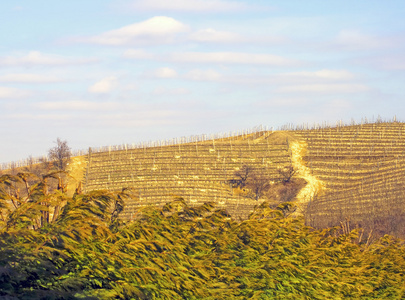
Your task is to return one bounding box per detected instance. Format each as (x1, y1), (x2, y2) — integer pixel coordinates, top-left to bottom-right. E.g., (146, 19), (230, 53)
(0, 173), (405, 299)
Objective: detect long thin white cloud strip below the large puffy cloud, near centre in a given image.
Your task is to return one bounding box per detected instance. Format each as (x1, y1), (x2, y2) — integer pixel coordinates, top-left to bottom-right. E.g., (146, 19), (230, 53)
(169, 52), (299, 66)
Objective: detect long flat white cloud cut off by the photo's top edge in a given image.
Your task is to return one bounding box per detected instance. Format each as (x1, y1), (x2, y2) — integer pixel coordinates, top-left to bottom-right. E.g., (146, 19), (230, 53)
(132, 0), (249, 12)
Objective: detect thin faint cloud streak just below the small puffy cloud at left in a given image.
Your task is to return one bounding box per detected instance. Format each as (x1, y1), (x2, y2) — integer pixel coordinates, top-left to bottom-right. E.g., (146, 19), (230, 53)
(35, 100), (117, 111)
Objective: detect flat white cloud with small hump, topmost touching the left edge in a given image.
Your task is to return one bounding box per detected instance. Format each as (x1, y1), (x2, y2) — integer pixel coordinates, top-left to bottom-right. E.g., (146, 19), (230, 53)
(0, 51), (97, 66)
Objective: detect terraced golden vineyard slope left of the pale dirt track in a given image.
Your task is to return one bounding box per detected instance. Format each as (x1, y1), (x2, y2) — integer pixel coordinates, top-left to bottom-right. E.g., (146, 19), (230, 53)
(85, 131), (290, 219)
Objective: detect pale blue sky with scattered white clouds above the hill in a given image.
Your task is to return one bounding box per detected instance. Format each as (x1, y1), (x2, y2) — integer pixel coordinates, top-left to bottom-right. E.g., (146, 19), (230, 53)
(0, 0), (405, 163)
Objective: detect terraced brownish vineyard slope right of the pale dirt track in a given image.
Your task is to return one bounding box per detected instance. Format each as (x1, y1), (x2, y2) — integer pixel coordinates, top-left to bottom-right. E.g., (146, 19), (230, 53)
(295, 122), (405, 236)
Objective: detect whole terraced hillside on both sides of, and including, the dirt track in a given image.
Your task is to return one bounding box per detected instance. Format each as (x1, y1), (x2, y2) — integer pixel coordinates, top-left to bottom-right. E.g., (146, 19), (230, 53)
(79, 122), (405, 236)
